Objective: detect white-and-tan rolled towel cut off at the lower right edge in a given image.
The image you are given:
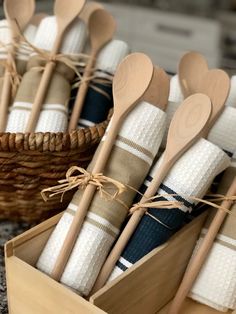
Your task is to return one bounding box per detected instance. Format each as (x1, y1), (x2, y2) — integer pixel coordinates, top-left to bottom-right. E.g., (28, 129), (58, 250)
(190, 167), (236, 312)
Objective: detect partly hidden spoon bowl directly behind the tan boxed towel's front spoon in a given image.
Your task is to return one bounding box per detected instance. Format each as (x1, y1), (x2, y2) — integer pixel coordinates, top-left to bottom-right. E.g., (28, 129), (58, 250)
(143, 67), (170, 111)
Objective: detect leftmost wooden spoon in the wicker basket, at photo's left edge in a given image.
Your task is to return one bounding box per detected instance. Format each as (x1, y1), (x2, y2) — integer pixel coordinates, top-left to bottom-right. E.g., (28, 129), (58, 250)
(0, 0), (35, 132)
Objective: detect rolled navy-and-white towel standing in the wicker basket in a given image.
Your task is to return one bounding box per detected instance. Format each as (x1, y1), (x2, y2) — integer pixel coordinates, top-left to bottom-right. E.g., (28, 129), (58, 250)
(71, 40), (130, 127)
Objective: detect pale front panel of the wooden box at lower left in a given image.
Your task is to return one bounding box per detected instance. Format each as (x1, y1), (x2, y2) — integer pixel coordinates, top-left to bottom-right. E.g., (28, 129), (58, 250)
(6, 256), (105, 314)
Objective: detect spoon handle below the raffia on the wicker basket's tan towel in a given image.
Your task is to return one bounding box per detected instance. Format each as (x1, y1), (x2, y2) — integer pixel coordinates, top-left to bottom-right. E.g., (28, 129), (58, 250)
(25, 61), (56, 133)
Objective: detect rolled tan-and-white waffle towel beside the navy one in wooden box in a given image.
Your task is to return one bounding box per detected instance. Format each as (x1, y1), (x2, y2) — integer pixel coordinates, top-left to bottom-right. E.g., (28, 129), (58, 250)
(37, 102), (166, 295)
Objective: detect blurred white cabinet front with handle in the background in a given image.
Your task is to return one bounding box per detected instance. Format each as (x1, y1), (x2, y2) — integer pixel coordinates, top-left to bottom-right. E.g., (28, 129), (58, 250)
(104, 3), (221, 72)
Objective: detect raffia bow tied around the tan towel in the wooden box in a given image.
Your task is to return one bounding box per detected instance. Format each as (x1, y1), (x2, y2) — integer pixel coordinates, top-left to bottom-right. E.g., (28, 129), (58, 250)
(41, 166), (126, 201)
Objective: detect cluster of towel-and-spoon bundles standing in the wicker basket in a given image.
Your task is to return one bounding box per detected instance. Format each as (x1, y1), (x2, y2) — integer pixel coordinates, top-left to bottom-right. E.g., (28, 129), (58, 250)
(0, 0), (129, 133)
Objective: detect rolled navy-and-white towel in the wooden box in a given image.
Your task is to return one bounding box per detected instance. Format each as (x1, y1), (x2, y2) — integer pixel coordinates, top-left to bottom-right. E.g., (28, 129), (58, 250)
(109, 139), (230, 281)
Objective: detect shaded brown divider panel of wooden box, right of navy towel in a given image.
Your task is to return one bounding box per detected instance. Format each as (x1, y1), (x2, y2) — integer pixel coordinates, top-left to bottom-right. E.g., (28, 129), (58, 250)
(90, 214), (206, 314)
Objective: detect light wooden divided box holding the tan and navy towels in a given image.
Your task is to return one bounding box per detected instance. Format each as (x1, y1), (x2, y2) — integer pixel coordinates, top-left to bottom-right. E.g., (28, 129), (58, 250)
(5, 210), (232, 314)
